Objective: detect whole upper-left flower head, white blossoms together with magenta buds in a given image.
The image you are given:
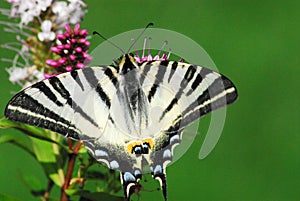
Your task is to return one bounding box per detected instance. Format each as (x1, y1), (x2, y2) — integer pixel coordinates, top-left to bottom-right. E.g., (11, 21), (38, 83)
(0, 0), (90, 87)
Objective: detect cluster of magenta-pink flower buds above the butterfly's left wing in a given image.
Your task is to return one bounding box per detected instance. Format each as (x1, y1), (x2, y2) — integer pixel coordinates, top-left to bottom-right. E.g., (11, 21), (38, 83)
(46, 24), (91, 77)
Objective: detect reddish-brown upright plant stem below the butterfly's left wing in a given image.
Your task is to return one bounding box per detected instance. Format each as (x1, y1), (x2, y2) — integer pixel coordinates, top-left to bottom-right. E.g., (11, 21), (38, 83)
(60, 138), (82, 201)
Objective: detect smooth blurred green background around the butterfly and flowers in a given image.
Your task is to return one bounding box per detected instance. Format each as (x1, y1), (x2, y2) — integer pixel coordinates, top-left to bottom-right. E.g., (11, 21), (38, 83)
(0, 0), (300, 201)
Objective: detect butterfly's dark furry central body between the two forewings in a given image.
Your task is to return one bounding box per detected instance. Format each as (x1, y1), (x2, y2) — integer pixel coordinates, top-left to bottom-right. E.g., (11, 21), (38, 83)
(112, 54), (149, 139)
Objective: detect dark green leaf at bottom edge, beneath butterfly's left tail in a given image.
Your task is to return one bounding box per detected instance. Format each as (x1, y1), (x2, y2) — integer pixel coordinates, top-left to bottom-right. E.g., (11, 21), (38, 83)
(67, 190), (124, 201)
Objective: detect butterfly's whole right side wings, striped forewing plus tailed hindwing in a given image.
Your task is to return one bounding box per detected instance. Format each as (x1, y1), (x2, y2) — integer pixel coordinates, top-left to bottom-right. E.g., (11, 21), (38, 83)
(136, 61), (237, 199)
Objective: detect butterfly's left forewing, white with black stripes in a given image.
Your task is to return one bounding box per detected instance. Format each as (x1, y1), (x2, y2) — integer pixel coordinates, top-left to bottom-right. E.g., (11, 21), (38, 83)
(5, 67), (114, 140)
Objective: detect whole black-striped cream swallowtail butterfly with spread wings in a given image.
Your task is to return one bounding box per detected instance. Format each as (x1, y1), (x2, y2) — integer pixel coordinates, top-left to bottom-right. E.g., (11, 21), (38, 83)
(5, 27), (237, 201)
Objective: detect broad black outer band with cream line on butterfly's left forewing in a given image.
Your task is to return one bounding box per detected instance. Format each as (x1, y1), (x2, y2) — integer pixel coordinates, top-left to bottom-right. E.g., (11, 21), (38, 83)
(5, 91), (79, 139)
